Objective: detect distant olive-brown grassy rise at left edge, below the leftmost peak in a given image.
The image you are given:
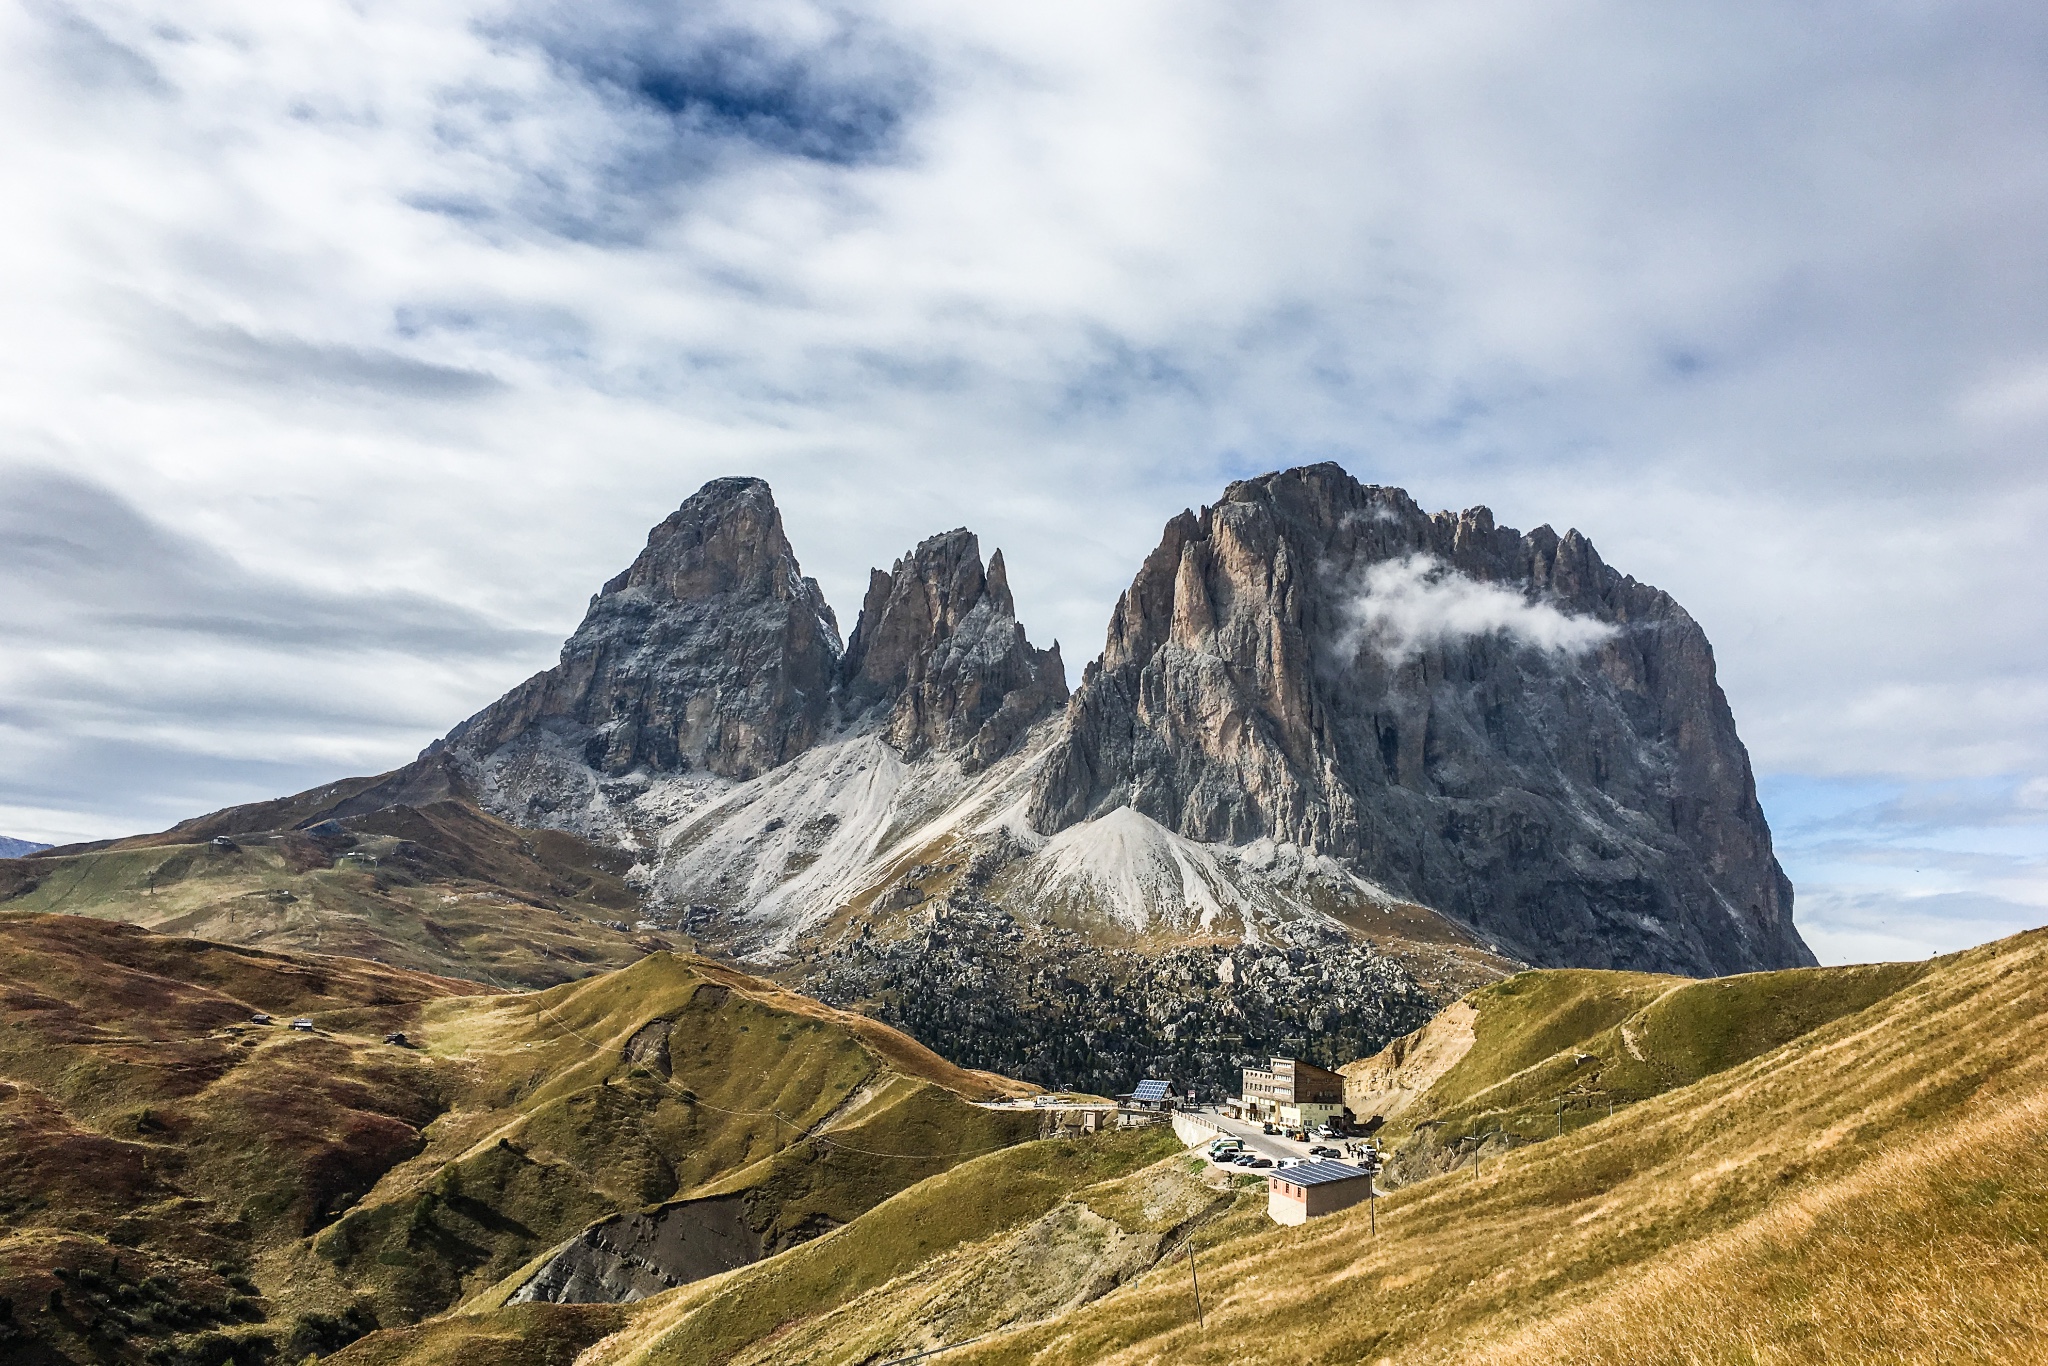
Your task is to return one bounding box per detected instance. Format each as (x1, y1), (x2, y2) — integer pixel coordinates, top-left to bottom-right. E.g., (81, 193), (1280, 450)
(0, 784), (662, 987)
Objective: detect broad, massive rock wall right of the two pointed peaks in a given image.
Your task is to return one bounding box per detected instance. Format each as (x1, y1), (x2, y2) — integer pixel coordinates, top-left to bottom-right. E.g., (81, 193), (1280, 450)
(1030, 465), (1812, 973)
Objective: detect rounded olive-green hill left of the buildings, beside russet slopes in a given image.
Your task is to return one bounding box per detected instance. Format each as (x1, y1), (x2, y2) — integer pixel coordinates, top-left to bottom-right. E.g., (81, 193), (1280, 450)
(280, 954), (1036, 1321)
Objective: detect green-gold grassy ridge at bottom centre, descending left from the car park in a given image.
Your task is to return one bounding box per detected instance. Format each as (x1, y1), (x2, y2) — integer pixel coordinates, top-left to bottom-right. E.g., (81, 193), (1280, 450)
(323, 1128), (1196, 1366)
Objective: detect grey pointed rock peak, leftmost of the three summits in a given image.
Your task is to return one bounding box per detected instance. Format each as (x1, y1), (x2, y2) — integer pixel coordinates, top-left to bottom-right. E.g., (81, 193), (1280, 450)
(446, 479), (840, 778)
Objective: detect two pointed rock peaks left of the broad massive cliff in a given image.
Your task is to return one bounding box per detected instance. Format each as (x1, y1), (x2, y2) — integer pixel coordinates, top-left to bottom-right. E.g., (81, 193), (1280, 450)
(440, 479), (1067, 838)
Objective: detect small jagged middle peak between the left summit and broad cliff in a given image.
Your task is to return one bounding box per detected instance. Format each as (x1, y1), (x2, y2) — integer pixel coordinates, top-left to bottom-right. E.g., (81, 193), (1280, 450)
(842, 528), (1067, 770)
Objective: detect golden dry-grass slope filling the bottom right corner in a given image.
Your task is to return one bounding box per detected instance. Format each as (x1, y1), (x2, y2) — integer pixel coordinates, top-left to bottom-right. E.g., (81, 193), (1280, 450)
(888, 932), (2048, 1364)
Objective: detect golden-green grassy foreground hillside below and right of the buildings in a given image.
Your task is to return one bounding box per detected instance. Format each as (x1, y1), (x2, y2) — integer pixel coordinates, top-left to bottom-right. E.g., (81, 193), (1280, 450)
(303, 932), (2048, 1366)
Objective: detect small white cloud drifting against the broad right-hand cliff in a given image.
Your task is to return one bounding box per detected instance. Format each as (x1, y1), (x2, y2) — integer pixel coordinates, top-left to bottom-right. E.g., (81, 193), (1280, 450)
(1339, 555), (1620, 664)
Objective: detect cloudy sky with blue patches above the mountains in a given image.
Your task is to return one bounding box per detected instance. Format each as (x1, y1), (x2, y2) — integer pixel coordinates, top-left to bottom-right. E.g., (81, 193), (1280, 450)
(0, 0), (2048, 963)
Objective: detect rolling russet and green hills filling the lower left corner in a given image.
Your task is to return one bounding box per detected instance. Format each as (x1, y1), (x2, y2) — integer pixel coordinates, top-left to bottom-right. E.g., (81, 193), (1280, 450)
(0, 915), (1036, 1362)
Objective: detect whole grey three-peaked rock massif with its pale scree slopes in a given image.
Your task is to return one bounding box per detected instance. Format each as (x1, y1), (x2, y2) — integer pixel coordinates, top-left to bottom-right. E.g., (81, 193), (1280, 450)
(411, 465), (1810, 973)
